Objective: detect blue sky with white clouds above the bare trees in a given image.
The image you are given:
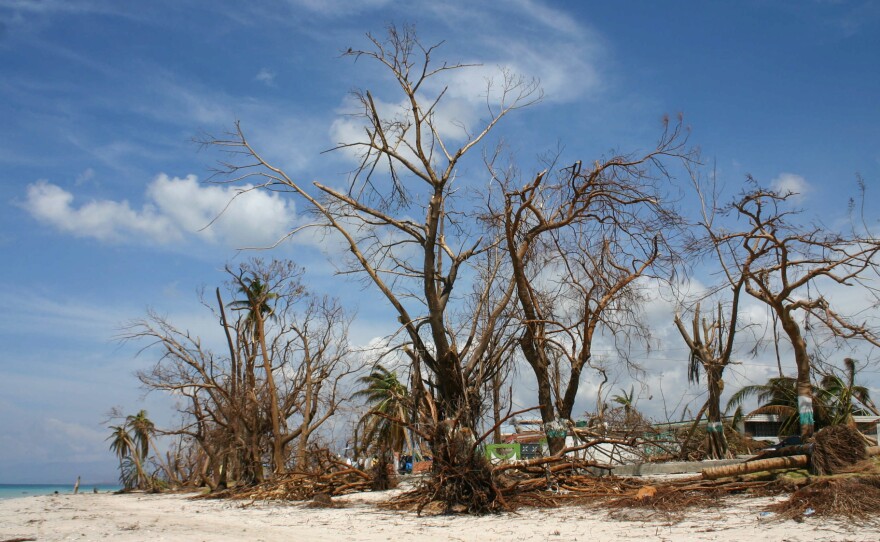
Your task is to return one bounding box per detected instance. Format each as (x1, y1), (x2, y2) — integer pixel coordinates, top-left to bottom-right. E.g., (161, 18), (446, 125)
(0, 0), (880, 483)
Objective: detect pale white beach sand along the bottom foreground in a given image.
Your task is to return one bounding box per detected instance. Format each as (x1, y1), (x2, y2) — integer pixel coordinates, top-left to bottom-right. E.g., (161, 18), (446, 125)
(0, 493), (880, 542)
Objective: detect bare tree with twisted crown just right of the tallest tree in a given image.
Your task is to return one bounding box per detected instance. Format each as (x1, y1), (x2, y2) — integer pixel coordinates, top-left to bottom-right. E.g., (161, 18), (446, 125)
(496, 119), (689, 453)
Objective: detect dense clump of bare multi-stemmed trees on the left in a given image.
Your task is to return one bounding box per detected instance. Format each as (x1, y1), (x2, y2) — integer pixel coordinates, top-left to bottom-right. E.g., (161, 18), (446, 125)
(123, 260), (356, 487)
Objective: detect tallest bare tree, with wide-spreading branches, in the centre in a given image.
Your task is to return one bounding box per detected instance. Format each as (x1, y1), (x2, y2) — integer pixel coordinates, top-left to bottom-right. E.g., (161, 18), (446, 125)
(205, 27), (541, 510)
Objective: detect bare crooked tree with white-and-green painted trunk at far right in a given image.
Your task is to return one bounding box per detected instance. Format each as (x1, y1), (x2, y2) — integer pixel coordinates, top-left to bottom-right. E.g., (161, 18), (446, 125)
(704, 178), (880, 438)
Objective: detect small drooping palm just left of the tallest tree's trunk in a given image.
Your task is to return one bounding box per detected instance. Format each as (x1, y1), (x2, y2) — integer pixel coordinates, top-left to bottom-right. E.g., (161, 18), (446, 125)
(352, 365), (413, 460)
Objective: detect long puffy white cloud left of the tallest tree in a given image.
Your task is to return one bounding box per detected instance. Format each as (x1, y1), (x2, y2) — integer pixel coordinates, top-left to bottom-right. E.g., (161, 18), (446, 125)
(20, 174), (295, 248)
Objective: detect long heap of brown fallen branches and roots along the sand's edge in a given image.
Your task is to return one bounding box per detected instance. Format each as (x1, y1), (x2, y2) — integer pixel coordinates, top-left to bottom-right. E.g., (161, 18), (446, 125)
(201, 423), (880, 520)
